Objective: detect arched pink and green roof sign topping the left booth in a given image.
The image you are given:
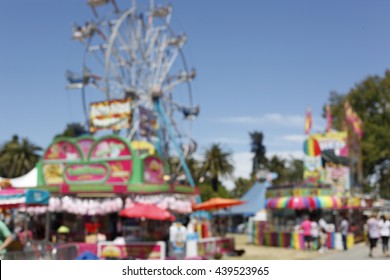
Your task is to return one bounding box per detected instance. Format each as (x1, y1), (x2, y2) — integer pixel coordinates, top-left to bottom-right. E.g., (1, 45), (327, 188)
(37, 135), (197, 196)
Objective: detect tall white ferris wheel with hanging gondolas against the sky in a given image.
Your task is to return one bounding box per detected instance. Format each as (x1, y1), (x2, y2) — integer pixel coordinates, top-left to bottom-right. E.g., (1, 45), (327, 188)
(66, 0), (199, 185)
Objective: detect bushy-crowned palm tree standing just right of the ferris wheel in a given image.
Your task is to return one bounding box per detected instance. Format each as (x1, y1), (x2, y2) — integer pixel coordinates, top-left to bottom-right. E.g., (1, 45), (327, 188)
(202, 143), (234, 191)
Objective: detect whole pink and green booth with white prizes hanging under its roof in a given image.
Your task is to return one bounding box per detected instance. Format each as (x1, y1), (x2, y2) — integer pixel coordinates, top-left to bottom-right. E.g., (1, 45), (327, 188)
(29, 135), (181, 256)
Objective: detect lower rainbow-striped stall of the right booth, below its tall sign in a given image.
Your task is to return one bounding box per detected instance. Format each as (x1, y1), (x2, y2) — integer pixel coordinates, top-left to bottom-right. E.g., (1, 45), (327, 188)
(252, 185), (371, 250)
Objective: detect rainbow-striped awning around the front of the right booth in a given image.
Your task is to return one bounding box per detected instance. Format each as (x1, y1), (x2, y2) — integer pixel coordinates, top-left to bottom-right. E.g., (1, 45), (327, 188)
(266, 196), (342, 210)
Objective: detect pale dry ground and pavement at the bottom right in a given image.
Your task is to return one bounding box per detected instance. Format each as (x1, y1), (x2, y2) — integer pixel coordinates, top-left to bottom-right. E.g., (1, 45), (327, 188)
(223, 234), (390, 260)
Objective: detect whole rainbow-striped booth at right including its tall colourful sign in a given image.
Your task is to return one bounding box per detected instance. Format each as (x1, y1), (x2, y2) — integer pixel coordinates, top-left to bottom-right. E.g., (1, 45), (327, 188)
(253, 124), (373, 249)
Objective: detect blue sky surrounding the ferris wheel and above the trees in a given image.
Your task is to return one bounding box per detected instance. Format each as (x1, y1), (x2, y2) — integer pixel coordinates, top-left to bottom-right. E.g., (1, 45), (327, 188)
(0, 0), (390, 186)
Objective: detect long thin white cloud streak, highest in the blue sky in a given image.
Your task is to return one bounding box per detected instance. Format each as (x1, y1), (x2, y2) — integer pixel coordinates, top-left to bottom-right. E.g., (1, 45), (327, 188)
(218, 113), (304, 129)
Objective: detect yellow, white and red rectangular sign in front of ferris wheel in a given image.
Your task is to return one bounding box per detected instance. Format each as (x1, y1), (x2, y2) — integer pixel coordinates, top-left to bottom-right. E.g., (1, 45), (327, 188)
(90, 98), (131, 133)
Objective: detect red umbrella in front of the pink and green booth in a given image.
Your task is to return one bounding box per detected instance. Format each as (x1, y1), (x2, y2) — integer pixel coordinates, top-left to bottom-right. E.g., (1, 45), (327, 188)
(119, 203), (175, 221)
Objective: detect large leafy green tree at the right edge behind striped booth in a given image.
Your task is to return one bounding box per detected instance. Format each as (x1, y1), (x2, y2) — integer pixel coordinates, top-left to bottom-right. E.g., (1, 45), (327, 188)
(329, 71), (390, 197)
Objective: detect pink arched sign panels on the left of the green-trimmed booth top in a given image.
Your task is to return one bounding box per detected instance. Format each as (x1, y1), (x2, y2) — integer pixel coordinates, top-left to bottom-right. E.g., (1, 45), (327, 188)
(42, 135), (133, 186)
